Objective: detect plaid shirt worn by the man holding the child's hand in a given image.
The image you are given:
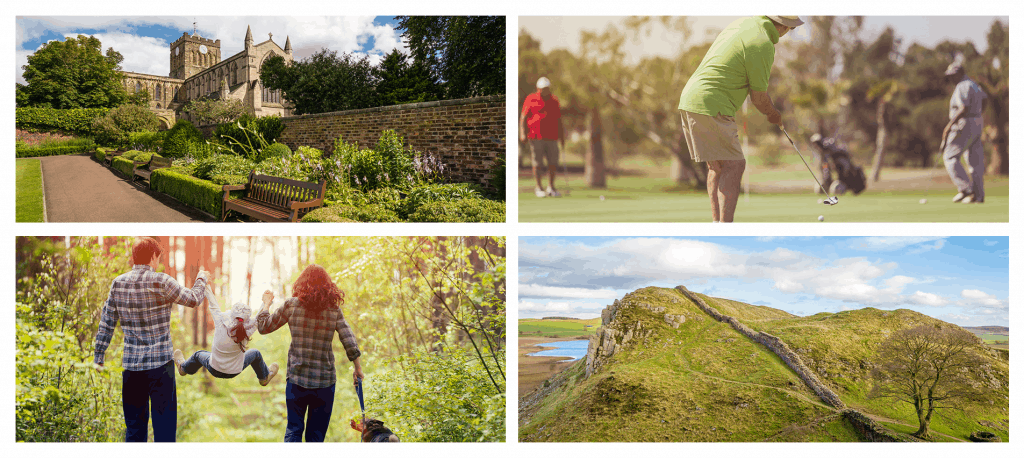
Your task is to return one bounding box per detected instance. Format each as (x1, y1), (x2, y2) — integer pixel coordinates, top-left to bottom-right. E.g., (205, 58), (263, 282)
(94, 264), (206, 371)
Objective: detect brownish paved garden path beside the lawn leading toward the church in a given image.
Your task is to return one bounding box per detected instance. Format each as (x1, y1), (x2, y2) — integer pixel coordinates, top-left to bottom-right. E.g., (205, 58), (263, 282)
(39, 155), (211, 222)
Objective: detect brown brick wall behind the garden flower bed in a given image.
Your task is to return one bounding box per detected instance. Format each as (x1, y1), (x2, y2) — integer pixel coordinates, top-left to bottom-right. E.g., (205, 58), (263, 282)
(278, 95), (505, 184)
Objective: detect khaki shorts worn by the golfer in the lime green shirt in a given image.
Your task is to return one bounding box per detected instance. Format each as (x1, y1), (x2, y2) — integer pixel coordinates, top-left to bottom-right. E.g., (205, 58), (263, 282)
(679, 110), (743, 162)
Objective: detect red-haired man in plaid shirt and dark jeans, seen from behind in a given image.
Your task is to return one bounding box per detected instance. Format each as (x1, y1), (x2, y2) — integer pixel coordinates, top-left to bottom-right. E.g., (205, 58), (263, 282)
(94, 237), (209, 442)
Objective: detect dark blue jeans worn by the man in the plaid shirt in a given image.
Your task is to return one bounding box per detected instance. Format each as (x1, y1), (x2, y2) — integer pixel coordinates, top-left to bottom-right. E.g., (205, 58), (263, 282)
(121, 361), (178, 442)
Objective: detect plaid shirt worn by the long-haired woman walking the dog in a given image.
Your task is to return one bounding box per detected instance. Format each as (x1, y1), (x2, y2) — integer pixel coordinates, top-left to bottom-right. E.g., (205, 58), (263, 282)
(256, 297), (361, 389)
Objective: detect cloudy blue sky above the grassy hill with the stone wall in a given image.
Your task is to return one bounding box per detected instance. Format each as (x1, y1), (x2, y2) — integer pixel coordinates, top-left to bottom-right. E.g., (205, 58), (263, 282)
(518, 237), (1010, 326)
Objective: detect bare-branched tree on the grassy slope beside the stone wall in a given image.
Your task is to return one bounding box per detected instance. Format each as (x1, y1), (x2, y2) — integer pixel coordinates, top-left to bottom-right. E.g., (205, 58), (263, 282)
(869, 325), (990, 438)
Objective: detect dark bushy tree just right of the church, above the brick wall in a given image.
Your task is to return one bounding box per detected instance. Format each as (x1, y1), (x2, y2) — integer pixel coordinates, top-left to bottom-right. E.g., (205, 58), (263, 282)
(260, 48), (378, 115)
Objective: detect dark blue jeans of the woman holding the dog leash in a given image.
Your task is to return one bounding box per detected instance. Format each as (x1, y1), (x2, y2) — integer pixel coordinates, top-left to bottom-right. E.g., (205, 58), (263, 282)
(285, 380), (334, 442)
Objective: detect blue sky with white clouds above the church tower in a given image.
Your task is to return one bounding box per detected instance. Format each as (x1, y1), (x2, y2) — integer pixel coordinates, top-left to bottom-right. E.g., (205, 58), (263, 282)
(14, 16), (408, 84)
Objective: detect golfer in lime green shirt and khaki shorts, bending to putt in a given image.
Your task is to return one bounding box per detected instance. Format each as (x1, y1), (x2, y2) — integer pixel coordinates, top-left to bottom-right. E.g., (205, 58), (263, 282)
(679, 16), (804, 222)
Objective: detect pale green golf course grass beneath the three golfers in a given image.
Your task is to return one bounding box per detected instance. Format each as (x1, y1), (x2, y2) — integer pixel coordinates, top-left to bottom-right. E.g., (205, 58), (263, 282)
(519, 172), (1010, 223)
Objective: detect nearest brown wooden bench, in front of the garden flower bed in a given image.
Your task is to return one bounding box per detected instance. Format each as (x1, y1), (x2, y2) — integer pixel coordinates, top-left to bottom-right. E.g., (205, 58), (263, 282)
(220, 170), (327, 222)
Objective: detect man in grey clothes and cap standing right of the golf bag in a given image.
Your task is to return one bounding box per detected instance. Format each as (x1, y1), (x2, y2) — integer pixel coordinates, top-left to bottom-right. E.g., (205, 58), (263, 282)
(939, 58), (988, 204)
